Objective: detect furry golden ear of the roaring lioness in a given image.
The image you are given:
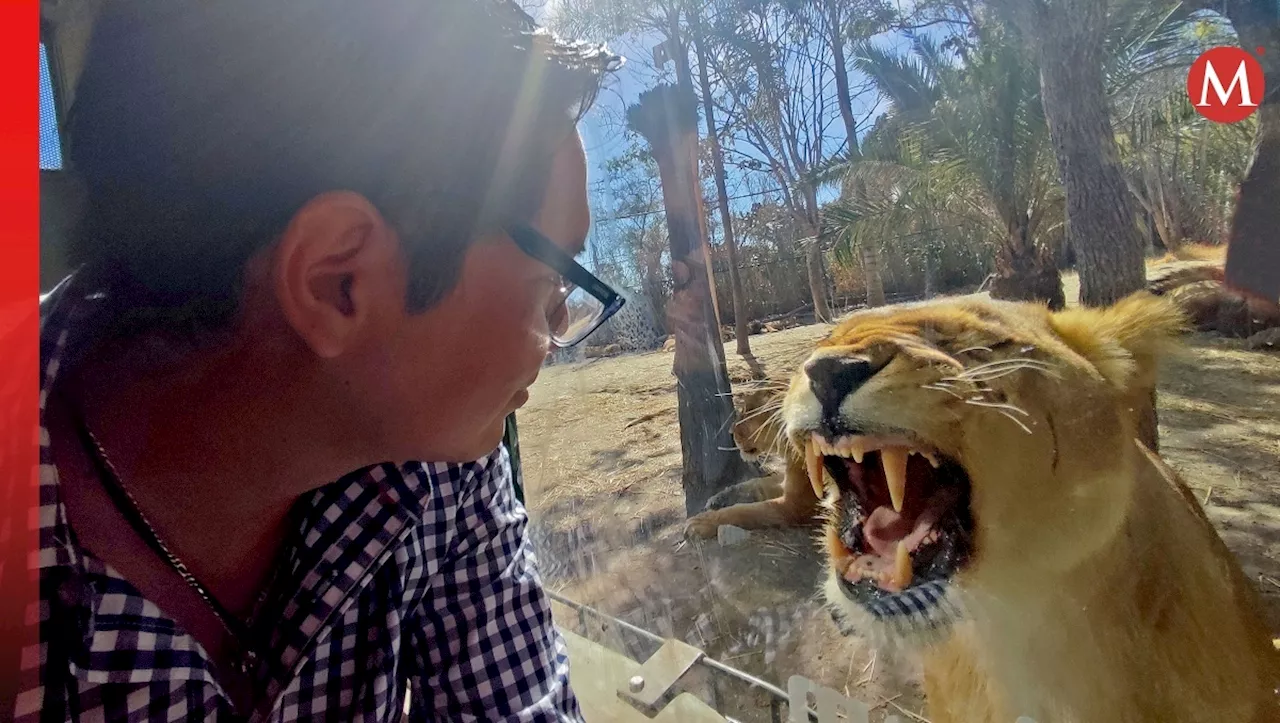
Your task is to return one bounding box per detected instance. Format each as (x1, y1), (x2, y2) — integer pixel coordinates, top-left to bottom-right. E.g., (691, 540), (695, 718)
(1050, 292), (1187, 389)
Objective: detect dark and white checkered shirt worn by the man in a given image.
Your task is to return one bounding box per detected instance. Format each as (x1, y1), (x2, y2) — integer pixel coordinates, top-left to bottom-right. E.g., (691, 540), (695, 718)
(8, 276), (581, 723)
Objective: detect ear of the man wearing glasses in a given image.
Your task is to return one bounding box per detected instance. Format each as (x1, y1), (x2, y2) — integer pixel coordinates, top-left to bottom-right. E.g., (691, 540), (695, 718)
(271, 191), (404, 358)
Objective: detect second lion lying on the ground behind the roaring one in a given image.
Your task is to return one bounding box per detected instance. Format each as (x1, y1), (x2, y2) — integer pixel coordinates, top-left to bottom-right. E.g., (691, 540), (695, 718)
(685, 380), (820, 537)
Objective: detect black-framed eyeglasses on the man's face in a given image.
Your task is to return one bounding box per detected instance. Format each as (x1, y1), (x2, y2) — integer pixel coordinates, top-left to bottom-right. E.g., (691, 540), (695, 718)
(507, 225), (626, 348)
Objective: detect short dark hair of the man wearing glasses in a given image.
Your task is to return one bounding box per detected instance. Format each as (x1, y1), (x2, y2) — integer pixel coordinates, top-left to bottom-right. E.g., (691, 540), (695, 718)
(67, 0), (621, 330)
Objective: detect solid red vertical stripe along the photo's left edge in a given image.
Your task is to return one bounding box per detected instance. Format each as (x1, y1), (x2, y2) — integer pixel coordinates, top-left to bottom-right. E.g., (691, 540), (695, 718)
(0, 0), (40, 720)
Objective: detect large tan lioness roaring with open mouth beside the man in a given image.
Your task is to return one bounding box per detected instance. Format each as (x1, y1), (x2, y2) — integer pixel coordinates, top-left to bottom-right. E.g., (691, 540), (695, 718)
(782, 293), (1280, 723)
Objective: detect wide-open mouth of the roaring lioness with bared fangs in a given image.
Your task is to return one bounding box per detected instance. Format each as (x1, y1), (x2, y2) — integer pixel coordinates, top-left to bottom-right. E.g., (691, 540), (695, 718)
(805, 434), (973, 617)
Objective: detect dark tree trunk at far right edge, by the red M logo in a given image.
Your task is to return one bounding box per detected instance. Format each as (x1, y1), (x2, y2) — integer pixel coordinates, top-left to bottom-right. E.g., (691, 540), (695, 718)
(1215, 0), (1280, 299)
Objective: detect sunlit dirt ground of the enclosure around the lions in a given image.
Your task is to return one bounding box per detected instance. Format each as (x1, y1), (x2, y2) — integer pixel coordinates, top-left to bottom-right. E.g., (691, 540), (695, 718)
(520, 278), (1280, 722)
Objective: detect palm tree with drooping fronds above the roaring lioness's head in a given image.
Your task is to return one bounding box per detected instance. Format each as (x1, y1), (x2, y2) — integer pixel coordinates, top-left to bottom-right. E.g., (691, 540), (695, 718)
(826, 23), (1064, 308)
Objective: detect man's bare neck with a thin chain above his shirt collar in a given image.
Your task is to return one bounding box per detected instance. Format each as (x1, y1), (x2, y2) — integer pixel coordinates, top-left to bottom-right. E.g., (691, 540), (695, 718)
(69, 332), (358, 612)
